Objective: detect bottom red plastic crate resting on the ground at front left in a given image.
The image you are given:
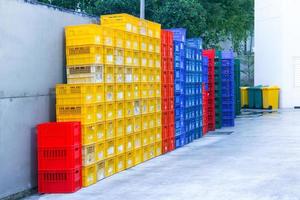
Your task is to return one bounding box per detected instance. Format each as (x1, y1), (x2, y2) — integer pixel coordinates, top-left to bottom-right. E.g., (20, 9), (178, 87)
(38, 167), (82, 193)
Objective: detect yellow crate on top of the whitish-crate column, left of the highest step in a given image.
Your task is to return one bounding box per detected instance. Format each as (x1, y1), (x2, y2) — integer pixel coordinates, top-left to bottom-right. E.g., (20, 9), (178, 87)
(65, 24), (103, 46)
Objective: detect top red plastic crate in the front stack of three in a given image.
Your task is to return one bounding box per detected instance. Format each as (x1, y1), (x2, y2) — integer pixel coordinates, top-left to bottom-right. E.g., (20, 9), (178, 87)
(37, 122), (81, 148)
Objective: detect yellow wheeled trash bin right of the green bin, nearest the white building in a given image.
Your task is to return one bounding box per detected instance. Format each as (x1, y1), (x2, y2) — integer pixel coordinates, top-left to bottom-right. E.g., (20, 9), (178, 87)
(262, 86), (280, 110)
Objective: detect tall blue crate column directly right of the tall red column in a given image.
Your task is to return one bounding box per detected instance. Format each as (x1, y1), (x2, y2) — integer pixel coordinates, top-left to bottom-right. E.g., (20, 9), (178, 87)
(169, 28), (186, 148)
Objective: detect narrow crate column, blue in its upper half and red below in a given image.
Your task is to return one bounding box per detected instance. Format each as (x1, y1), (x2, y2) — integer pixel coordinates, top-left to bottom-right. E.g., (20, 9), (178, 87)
(202, 56), (209, 135)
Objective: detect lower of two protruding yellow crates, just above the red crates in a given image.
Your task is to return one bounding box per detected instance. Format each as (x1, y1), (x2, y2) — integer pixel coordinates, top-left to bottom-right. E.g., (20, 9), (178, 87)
(56, 104), (96, 125)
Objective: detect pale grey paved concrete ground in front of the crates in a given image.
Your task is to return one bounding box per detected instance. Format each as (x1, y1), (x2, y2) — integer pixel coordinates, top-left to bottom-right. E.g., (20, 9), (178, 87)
(28, 111), (300, 200)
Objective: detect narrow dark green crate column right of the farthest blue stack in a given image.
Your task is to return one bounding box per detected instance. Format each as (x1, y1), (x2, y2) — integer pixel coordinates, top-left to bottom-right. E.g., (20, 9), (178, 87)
(234, 59), (241, 115)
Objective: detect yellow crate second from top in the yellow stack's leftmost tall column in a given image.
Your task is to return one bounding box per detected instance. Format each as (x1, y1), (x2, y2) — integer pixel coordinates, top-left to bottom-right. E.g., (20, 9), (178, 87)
(66, 45), (104, 66)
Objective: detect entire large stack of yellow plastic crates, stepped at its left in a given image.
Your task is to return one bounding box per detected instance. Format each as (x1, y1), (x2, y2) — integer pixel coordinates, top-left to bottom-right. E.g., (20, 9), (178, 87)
(56, 14), (161, 186)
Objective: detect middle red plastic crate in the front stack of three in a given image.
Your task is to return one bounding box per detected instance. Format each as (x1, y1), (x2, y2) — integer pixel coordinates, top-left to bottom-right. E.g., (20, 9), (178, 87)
(38, 145), (82, 170)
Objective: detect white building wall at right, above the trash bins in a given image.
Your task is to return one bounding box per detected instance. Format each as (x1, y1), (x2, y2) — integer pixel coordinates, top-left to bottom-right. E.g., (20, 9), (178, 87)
(254, 0), (300, 108)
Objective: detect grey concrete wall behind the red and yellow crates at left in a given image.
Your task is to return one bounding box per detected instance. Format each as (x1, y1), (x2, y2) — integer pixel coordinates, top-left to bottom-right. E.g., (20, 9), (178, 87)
(0, 0), (96, 198)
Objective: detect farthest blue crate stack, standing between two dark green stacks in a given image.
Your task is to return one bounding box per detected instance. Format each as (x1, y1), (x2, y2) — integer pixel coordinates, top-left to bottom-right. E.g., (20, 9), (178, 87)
(221, 51), (235, 127)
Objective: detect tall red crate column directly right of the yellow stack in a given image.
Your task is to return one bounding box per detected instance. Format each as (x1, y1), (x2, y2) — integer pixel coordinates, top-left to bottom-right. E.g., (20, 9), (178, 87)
(161, 30), (175, 153)
